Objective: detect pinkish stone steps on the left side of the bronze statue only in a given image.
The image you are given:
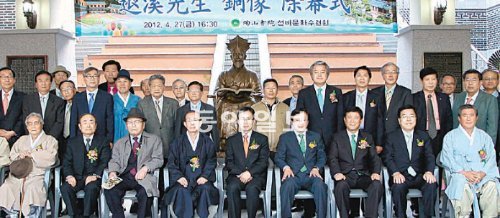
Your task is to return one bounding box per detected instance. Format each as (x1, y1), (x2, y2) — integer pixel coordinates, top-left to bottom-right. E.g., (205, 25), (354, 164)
(78, 35), (216, 100)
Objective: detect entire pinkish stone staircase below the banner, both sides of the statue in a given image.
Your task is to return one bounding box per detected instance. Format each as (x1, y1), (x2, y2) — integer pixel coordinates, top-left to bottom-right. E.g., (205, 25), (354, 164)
(77, 34), (397, 100)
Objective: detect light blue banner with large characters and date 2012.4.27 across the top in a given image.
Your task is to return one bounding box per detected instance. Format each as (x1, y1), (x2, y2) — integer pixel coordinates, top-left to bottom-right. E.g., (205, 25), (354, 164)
(75, 0), (398, 36)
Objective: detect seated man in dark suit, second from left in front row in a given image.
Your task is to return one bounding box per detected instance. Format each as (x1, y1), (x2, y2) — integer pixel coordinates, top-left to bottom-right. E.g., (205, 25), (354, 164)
(61, 114), (111, 217)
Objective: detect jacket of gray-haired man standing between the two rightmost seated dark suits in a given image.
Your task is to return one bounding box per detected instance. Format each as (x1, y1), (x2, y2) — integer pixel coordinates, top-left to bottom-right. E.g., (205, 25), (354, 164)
(373, 85), (413, 136)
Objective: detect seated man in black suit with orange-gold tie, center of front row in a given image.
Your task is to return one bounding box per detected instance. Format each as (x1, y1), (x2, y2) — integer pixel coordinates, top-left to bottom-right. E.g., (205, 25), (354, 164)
(226, 107), (269, 218)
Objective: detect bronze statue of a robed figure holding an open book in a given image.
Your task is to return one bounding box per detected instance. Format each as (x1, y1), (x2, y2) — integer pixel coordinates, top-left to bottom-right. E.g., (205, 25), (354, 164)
(216, 36), (261, 151)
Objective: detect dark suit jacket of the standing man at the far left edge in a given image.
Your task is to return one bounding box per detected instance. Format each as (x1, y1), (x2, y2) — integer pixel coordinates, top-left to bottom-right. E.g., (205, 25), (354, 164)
(0, 89), (25, 146)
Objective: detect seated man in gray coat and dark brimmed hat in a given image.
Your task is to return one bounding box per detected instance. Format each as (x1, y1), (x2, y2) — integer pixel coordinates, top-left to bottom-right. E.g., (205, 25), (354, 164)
(104, 108), (163, 218)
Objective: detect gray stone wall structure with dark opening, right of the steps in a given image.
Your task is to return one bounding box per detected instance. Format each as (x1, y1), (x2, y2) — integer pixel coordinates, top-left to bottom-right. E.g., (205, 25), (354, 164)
(397, 25), (473, 92)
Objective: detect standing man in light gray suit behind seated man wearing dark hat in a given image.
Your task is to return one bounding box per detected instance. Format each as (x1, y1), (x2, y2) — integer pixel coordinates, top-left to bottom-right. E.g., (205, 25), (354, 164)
(138, 74), (179, 160)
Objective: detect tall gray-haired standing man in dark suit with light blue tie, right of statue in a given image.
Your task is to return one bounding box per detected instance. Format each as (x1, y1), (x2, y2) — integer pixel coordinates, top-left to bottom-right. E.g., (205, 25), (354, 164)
(297, 61), (344, 151)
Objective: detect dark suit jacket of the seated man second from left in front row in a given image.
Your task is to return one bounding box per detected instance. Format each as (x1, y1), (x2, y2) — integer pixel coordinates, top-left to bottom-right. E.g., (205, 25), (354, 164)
(62, 135), (111, 180)
